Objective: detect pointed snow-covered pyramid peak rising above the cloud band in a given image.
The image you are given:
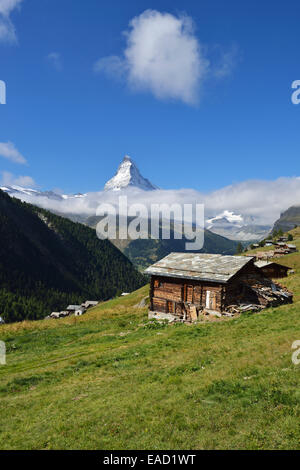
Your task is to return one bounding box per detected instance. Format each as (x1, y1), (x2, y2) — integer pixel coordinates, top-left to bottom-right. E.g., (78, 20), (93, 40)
(104, 155), (157, 191)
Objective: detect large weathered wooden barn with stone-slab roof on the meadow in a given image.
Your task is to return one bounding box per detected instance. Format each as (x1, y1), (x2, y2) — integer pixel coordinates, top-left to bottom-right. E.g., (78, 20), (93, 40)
(145, 253), (291, 321)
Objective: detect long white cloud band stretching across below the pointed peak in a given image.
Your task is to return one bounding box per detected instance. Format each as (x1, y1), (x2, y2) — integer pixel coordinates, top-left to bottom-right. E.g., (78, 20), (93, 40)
(6, 177), (300, 225)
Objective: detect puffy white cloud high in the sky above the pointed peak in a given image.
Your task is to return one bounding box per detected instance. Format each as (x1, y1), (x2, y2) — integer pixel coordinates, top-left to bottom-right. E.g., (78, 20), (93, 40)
(94, 10), (209, 105)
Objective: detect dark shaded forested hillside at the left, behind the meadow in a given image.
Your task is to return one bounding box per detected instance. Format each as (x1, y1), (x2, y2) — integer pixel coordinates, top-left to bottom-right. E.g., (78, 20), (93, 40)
(0, 191), (145, 322)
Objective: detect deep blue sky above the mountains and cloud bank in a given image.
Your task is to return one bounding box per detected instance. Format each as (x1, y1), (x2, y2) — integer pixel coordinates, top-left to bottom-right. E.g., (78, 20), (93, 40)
(0, 0), (300, 193)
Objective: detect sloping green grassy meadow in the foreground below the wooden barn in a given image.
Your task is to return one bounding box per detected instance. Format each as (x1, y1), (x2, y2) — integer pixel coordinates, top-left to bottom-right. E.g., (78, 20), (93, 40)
(0, 229), (300, 449)
